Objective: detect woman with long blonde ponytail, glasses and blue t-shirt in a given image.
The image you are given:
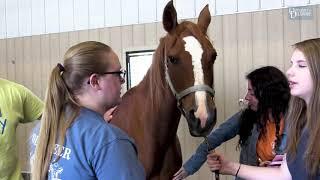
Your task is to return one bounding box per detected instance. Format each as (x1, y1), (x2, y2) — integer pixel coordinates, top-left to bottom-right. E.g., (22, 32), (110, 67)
(31, 41), (145, 180)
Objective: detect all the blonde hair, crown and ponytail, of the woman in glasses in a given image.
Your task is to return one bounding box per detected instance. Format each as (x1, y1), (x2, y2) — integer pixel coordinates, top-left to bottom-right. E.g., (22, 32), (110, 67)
(31, 41), (113, 180)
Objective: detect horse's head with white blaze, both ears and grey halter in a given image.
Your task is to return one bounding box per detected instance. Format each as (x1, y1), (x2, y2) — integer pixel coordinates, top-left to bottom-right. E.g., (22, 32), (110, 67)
(162, 1), (217, 136)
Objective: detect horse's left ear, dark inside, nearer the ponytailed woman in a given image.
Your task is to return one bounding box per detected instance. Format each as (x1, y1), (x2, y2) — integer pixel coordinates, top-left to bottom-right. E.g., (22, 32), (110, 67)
(162, 0), (178, 33)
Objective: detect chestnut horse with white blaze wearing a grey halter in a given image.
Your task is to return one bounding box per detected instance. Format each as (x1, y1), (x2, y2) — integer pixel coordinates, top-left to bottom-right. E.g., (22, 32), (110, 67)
(111, 1), (217, 180)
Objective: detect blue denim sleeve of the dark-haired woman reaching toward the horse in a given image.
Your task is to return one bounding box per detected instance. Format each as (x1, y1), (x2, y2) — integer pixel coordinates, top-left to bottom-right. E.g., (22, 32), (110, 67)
(183, 112), (241, 175)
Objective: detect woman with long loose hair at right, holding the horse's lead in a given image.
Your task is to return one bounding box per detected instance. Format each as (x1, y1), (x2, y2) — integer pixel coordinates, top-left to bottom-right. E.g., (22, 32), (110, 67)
(207, 38), (320, 180)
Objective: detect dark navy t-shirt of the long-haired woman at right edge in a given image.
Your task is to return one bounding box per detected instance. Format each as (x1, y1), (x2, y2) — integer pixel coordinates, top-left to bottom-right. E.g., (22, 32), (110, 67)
(287, 129), (320, 180)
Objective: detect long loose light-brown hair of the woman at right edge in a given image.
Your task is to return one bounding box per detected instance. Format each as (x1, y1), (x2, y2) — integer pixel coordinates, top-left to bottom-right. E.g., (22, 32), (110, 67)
(286, 38), (320, 176)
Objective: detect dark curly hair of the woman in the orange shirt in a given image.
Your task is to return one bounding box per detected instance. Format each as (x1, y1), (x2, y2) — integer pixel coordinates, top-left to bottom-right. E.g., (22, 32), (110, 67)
(239, 66), (290, 151)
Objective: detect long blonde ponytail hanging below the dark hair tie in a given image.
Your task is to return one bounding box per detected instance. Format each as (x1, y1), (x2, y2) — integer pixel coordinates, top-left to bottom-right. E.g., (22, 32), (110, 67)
(31, 66), (79, 180)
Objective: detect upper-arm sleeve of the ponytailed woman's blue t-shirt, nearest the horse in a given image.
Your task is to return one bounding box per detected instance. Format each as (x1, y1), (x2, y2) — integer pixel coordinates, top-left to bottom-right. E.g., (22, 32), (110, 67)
(92, 139), (145, 180)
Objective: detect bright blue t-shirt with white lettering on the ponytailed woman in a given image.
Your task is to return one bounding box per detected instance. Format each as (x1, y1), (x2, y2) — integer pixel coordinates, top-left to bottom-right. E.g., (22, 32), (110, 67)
(31, 108), (145, 180)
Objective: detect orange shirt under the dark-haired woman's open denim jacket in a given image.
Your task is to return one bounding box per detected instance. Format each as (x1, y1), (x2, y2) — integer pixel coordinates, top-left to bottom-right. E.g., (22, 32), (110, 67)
(257, 118), (284, 161)
